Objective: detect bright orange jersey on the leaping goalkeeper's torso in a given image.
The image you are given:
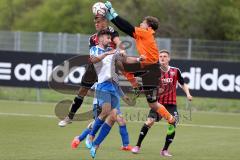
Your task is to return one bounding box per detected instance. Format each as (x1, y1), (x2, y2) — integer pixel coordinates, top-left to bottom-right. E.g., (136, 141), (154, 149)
(133, 27), (159, 65)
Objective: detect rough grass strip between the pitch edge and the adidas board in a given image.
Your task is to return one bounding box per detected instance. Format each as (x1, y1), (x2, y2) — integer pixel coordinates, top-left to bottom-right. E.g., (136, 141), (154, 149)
(0, 86), (240, 113)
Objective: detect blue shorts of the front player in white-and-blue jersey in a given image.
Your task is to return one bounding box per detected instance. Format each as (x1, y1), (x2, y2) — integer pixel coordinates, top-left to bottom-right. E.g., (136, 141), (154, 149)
(96, 81), (120, 109)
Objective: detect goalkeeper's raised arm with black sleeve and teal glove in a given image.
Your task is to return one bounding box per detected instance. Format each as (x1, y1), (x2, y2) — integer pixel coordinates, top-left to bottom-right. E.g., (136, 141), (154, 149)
(105, 1), (135, 37)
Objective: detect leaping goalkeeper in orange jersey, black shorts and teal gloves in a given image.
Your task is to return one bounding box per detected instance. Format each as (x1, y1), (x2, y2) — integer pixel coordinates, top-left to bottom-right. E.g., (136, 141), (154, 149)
(105, 1), (175, 123)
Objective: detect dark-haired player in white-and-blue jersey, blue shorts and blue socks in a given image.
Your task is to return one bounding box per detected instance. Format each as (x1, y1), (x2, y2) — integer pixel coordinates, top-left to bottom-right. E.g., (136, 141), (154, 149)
(86, 30), (124, 158)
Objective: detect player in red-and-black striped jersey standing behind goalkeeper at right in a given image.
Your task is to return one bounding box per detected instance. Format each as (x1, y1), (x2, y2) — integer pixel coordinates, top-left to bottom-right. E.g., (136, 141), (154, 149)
(132, 50), (192, 156)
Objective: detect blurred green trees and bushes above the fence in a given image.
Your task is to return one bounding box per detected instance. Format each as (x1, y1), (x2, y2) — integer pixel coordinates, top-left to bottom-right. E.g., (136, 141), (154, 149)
(0, 0), (240, 40)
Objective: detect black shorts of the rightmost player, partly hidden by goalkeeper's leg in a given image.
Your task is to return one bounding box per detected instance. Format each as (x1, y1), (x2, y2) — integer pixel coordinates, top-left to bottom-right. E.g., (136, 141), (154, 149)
(148, 104), (179, 122)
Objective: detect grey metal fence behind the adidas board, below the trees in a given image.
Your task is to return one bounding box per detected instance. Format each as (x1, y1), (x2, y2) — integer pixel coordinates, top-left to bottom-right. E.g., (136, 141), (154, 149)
(0, 31), (240, 61)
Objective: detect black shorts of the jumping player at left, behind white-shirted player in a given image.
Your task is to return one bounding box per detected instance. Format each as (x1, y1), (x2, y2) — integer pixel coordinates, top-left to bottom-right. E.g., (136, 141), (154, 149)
(81, 63), (97, 89)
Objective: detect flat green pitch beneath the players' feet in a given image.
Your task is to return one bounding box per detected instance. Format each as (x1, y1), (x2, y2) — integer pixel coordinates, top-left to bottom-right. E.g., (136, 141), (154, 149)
(0, 100), (240, 160)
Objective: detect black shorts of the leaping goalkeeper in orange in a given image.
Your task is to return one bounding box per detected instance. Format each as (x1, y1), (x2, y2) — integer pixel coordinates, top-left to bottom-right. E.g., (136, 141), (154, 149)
(123, 63), (161, 103)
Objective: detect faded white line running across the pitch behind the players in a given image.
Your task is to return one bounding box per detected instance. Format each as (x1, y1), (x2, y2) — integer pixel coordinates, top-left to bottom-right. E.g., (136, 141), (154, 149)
(0, 112), (240, 130)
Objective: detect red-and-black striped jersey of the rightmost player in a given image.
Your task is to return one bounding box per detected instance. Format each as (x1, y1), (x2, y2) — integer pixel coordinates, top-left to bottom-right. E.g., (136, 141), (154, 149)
(158, 66), (184, 105)
